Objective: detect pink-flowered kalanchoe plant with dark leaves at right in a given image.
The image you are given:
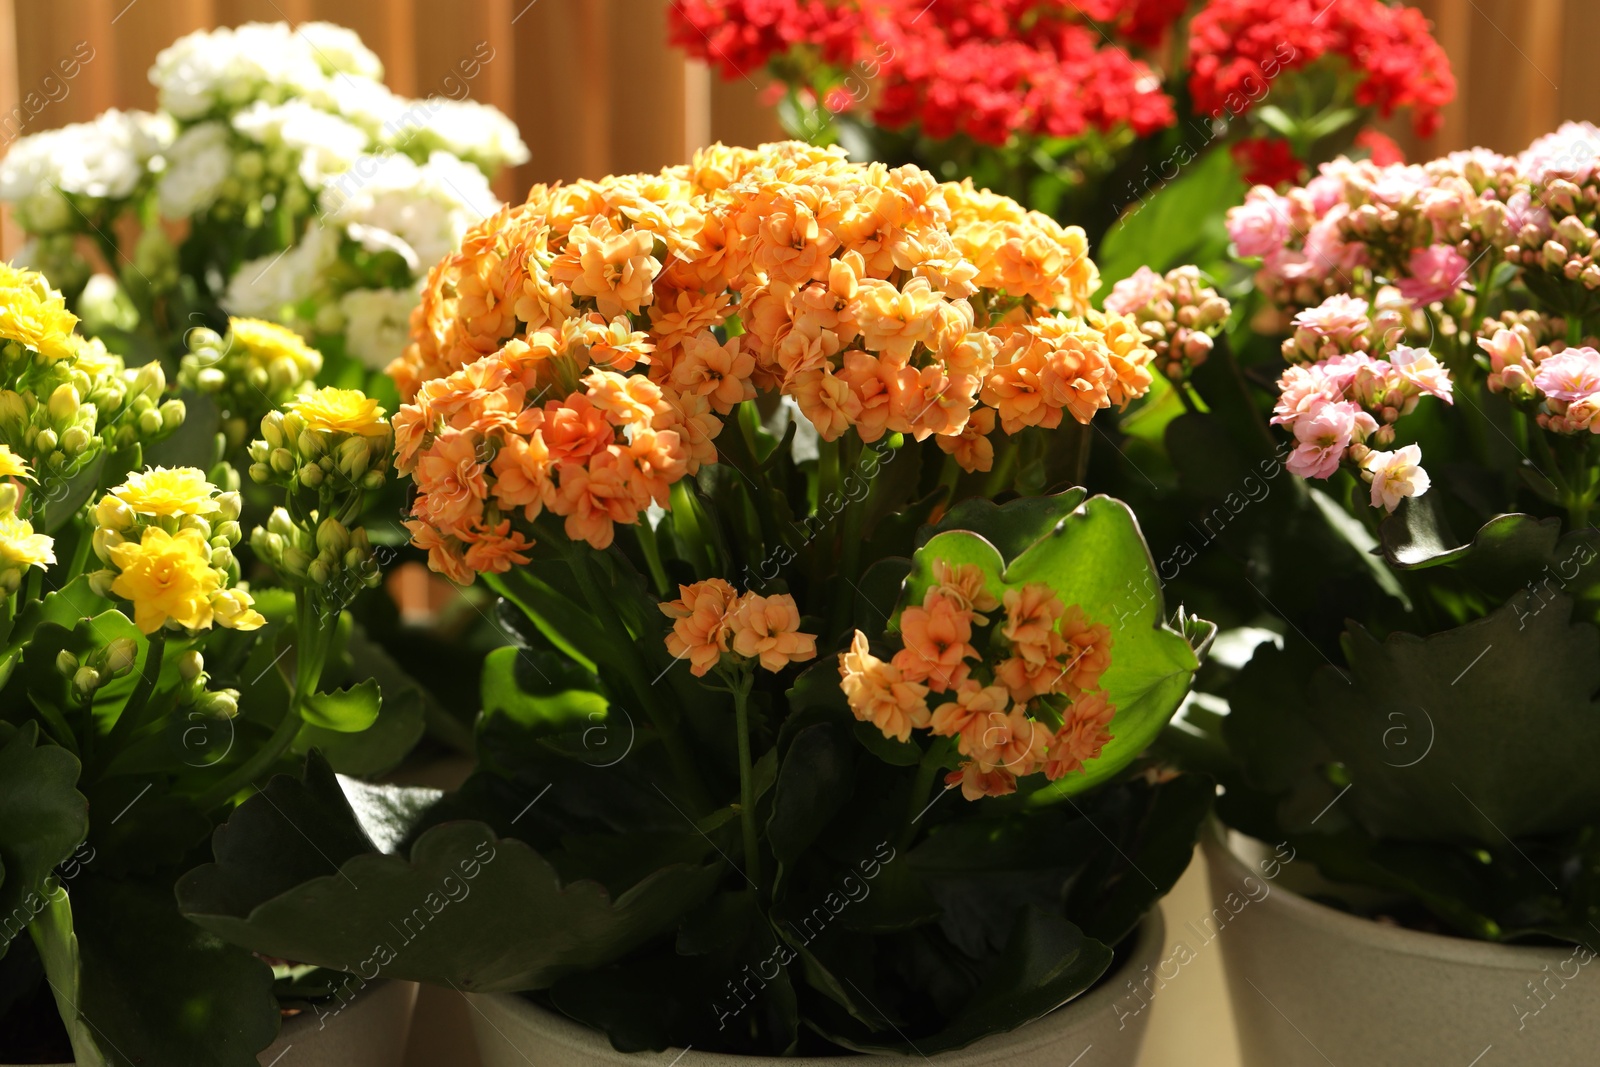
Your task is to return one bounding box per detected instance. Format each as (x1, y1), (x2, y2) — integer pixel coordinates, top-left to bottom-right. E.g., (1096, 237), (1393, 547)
(1100, 125), (1600, 944)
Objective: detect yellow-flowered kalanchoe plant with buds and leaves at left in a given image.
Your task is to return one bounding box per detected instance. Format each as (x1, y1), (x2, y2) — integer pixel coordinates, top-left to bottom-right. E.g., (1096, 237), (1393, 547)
(0, 267), (421, 1067)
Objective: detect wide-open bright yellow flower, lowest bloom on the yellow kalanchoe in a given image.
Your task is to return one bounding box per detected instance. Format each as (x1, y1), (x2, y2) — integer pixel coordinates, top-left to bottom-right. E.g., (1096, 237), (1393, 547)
(110, 526), (222, 633)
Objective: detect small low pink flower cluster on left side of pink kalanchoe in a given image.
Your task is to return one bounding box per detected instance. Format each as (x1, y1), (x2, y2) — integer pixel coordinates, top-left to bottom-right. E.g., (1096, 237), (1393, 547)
(1272, 290), (1454, 512)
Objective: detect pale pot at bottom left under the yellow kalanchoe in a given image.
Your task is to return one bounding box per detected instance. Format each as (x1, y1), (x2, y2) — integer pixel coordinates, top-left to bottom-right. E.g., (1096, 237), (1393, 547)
(0, 982), (416, 1067)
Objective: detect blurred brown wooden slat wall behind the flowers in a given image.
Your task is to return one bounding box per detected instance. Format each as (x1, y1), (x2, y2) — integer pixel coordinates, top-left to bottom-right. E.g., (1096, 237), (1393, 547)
(0, 0), (1600, 250)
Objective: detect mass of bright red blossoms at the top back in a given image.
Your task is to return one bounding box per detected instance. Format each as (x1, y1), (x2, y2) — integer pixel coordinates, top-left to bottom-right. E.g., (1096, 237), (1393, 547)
(670, 0), (1456, 184)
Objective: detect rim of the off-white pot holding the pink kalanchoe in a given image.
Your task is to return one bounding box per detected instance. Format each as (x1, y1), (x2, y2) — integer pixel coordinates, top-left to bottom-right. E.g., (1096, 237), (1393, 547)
(1200, 819), (1571, 971)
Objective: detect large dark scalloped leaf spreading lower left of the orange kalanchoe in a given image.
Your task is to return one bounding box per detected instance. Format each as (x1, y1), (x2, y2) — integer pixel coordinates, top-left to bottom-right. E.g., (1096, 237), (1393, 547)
(178, 761), (723, 992)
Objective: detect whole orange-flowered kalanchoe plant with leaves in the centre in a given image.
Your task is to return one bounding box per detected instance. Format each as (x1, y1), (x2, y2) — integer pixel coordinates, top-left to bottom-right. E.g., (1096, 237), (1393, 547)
(179, 142), (1211, 1054)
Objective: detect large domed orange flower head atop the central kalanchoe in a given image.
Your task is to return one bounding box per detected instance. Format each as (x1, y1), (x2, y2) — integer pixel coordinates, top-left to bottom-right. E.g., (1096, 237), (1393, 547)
(390, 142), (1152, 581)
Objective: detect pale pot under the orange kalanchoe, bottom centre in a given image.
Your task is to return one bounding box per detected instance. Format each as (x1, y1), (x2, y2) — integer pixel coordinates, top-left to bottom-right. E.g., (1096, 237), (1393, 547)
(467, 910), (1165, 1067)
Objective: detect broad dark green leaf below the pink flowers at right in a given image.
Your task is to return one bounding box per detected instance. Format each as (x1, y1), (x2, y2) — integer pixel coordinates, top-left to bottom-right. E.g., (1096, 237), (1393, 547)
(1309, 592), (1600, 845)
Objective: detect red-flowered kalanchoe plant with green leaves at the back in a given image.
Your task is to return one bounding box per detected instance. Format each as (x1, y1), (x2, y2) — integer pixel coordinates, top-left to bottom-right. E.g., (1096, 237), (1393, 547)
(669, 0), (1456, 243)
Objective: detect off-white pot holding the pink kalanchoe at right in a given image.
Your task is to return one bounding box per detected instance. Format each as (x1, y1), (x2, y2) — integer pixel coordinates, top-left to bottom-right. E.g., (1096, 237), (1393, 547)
(1195, 833), (1600, 1067)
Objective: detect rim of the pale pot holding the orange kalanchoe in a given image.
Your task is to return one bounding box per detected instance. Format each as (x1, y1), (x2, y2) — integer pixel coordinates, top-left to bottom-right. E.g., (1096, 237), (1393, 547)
(467, 902), (1166, 1067)
